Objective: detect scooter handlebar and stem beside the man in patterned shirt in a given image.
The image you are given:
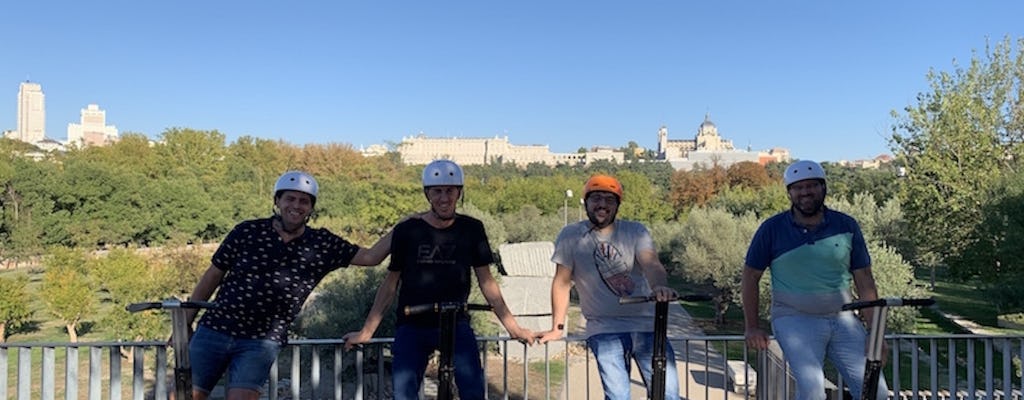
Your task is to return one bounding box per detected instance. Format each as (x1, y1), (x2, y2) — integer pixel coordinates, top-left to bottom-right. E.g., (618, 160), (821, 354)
(125, 298), (217, 400)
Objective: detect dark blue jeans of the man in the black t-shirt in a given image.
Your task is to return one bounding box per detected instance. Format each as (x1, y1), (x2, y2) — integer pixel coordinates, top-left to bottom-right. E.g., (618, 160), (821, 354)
(391, 321), (484, 400)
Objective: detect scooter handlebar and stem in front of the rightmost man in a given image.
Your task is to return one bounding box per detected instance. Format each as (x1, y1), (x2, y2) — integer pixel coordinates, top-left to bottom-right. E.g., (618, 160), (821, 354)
(843, 298), (935, 400)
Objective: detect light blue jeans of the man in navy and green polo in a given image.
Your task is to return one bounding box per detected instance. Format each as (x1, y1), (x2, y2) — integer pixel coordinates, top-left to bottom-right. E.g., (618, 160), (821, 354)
(772, 312), (889, 400)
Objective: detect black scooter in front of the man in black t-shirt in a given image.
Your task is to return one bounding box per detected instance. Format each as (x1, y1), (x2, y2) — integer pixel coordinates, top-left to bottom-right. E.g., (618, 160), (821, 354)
(403, 302), (492, 400)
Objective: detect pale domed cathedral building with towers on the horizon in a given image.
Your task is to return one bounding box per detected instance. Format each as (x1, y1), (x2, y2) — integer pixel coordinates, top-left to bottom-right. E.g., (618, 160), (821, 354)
(657, 115), (791, 170)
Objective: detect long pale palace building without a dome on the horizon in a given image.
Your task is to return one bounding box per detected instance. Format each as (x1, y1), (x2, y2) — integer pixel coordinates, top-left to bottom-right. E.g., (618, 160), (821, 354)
(397, 134), (626, 167)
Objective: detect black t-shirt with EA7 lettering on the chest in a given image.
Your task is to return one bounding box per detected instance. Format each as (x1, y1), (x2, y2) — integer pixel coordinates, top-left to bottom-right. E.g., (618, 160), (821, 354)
(388, 214), (495, 327)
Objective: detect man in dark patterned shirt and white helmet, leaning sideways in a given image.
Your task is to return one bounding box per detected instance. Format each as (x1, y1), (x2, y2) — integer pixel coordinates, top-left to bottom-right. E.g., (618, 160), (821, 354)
(188, 171), (391, 400)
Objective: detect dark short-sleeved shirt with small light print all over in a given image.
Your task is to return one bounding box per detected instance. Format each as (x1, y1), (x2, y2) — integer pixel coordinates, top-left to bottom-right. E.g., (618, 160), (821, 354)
(200, 218), (359, 343)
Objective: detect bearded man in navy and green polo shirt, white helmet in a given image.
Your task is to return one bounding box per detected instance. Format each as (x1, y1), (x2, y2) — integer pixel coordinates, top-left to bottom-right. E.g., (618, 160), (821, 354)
(741, 161), (889, 400)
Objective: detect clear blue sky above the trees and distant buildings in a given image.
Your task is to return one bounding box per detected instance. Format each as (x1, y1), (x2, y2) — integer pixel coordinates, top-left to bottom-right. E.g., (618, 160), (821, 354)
(0, 0), (1024, 161)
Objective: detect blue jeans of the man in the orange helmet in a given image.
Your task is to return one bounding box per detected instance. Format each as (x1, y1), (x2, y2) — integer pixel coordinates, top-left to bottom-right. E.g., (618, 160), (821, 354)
(587, 332), (679, 400)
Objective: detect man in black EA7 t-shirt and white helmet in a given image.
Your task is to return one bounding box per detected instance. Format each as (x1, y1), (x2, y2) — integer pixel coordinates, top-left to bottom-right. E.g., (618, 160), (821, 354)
(344, 160), (534, 400)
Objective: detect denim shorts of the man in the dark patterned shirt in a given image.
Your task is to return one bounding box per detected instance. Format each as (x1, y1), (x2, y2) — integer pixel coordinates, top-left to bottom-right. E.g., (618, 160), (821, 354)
(188, 326), (281, 393)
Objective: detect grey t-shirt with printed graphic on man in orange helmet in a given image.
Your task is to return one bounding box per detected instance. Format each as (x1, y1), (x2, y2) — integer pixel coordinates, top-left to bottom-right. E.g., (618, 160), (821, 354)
(551, 220), (654, 337)
